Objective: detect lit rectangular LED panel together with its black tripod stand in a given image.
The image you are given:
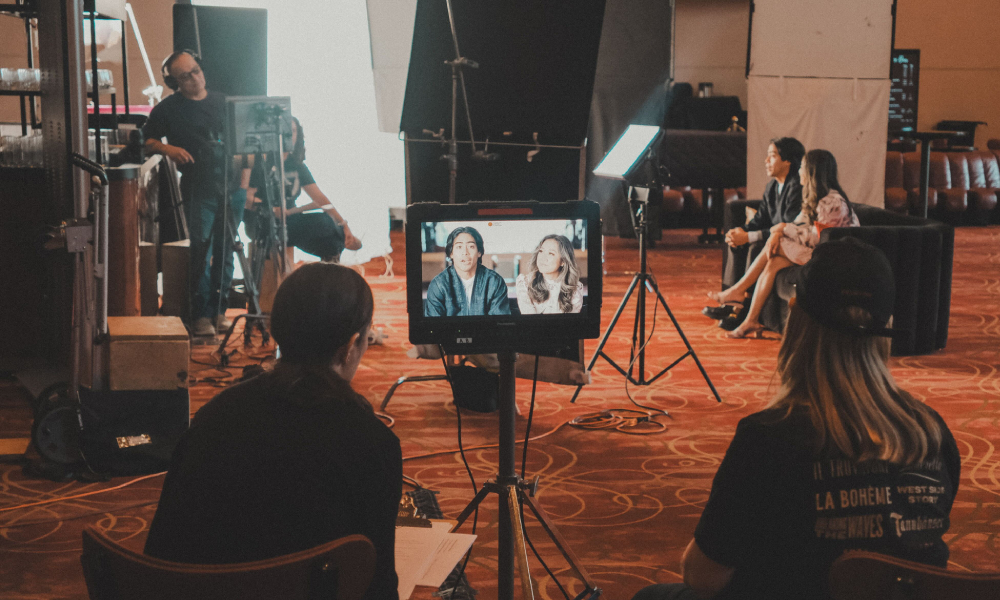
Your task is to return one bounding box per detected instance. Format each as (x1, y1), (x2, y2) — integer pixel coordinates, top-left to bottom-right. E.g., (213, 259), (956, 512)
(570, 125), (722, 402)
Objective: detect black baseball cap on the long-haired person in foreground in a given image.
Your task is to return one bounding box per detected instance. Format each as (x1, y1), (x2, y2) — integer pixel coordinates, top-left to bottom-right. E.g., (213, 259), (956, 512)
(795, 237), (901, 337)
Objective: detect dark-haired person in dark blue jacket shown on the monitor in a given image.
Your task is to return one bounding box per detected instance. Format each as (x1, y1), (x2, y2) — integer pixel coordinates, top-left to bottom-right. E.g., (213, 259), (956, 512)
(424, 227), (510, 317)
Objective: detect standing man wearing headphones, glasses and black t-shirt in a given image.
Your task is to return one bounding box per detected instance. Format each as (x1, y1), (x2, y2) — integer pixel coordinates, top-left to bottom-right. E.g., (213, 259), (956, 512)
(143, 50), (246, 336)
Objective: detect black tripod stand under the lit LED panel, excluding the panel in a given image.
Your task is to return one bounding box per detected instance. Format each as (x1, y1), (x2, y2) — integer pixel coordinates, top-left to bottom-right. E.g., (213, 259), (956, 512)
(570, 186), (722, 404)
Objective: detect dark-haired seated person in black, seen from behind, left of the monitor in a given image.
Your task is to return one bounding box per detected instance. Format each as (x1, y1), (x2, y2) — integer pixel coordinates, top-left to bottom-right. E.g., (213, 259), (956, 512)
(146, 263), (403, 600)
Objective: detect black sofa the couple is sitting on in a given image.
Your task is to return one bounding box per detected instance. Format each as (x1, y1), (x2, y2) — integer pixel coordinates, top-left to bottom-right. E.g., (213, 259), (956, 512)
(725, 200), (955, 356)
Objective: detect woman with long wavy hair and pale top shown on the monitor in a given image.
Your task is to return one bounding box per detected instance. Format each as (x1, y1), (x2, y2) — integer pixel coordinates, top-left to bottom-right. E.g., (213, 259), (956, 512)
(516, 235), (583, 315)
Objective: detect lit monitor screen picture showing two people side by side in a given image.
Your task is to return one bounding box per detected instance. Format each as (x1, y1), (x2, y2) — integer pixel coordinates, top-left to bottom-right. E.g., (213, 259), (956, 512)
(420, 219), (587, 317)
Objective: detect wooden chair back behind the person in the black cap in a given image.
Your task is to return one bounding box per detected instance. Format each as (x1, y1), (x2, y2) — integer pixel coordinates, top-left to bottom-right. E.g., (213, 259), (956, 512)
(830, 550), (1000, 600)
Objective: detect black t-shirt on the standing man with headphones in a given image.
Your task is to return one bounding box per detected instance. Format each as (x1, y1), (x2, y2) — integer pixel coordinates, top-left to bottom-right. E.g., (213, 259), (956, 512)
(142, 92), (226, 183)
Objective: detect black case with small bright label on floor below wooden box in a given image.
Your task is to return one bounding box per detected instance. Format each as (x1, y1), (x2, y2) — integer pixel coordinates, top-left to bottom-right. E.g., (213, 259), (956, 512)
(80, 388), (191, 475)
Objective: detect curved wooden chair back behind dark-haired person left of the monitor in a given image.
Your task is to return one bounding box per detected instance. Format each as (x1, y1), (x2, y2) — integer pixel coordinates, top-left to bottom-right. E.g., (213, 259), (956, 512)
(80, 526), (375, 600)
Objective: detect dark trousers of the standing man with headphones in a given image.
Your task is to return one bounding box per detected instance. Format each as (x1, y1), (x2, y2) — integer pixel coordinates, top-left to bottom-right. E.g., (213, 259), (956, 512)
(183, 189), (246, 322)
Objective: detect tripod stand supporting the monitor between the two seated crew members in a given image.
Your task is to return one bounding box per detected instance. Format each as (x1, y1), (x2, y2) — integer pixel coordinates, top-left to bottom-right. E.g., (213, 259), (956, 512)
(455, 350), (601, 600)
